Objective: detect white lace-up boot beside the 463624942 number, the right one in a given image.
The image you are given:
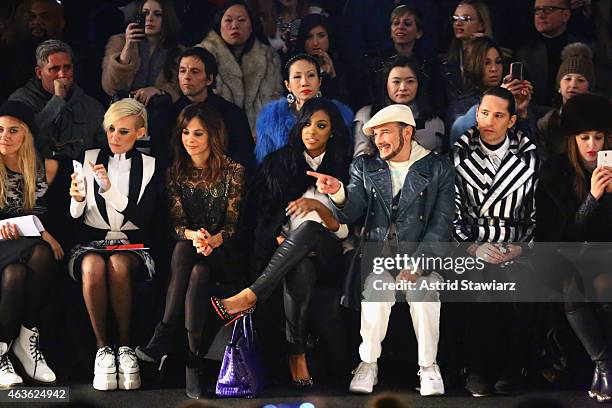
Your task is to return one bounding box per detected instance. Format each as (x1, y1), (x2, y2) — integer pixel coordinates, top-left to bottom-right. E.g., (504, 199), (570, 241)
(11, 326), (56, 385)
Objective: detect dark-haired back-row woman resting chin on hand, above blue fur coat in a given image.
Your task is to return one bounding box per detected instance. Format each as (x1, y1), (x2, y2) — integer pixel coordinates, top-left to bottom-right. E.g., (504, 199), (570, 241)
(295, 14), (349, 103)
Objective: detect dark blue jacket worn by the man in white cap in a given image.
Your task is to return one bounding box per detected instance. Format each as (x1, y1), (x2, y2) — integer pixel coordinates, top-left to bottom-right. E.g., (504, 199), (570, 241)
(334, 153), (455, 262)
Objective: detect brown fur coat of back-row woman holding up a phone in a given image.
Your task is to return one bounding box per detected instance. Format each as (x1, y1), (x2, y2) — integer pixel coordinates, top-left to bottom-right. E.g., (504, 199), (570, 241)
(102, 34), (180, 102)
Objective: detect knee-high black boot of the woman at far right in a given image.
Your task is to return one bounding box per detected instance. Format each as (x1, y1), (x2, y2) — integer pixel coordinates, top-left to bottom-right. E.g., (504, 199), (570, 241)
(565, 304), (612, 400)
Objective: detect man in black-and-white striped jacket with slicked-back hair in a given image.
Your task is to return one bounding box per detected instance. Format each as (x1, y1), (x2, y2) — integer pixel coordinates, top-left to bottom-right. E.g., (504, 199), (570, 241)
(453, 87), (538, 397)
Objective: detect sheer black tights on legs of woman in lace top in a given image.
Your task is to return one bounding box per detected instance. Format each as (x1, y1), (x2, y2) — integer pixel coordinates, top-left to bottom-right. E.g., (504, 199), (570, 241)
(163, 241), (219, 353)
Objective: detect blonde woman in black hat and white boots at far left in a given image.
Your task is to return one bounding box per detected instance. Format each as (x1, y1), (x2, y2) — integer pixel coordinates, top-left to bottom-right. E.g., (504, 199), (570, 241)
(0, 101), (64, 388)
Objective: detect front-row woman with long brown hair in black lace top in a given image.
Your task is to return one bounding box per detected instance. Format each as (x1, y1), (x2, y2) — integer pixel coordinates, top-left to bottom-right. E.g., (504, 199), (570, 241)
(136, 104), (246, 398)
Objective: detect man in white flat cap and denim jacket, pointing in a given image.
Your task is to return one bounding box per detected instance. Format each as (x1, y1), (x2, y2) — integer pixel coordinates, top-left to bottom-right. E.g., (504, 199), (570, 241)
(308, 105), (455, 396)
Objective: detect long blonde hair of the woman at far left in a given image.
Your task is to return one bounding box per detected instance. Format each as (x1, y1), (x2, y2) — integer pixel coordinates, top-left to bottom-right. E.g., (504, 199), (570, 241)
(0, 118), (40, 213)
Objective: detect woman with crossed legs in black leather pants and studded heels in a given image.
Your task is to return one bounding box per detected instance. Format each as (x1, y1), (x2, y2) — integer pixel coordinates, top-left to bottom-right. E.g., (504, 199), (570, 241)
(211, 98), (350, 387)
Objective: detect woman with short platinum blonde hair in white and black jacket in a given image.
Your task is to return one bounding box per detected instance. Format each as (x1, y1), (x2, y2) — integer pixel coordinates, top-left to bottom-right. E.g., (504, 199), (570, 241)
(68, 99), (162, 390)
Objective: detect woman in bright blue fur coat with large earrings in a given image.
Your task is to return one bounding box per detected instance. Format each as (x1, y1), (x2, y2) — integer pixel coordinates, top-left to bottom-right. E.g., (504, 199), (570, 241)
(255, 54), (354, 164)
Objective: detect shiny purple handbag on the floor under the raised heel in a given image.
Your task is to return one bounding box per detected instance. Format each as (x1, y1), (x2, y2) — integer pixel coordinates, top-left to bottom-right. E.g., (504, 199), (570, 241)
(215, 314), (262, 398)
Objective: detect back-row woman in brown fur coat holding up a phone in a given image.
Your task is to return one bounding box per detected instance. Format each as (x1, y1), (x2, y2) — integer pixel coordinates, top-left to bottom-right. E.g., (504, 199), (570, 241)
(102, 0), (180, 105)
